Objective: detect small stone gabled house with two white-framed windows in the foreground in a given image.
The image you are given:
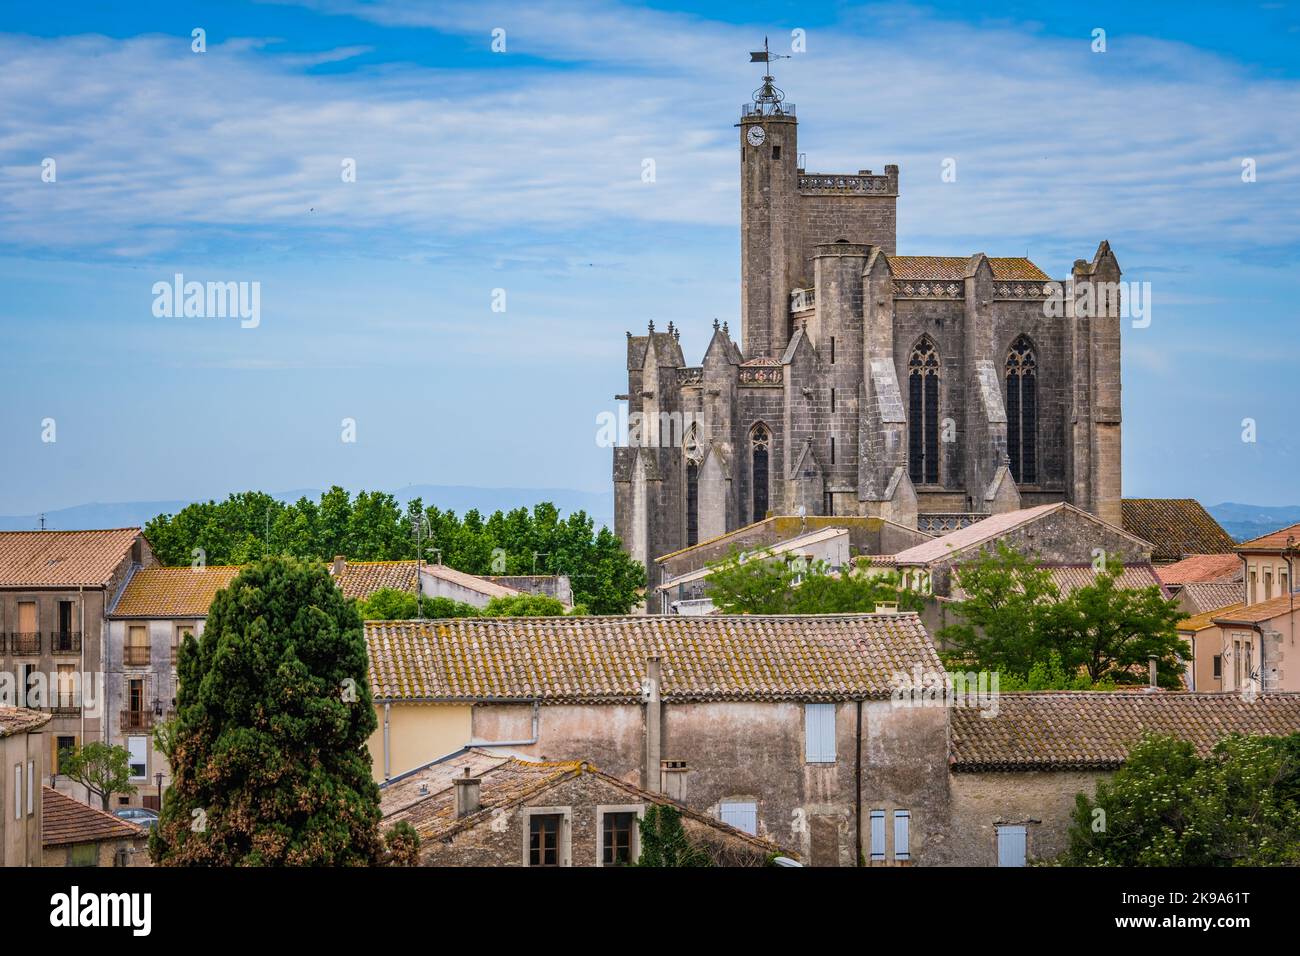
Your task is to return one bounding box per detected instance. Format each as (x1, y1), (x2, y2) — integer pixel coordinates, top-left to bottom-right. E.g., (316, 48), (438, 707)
(381, 748), (787, 868)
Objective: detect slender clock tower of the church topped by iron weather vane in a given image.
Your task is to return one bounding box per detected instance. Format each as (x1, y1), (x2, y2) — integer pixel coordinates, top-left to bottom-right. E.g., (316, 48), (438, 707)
(737, 43), (800, 359)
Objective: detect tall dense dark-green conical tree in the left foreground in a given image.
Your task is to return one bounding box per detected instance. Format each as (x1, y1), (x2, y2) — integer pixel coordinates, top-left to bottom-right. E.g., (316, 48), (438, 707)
(150, 558), (384, 866)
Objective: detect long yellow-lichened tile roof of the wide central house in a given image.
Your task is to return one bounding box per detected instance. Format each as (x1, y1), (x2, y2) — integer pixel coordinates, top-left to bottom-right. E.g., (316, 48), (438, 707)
(365, 614), (940, 704)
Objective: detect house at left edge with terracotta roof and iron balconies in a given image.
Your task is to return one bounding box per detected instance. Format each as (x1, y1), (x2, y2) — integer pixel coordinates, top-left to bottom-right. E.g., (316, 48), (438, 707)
(0, 528), (157, 800)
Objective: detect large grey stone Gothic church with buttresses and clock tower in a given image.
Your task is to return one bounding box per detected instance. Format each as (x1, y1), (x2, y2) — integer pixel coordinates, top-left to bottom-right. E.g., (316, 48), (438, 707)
(614, 74), (1121, 588)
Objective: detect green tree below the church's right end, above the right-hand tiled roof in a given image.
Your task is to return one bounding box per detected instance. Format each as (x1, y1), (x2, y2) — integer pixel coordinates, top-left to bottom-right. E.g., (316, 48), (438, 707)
(937, 545), (1187, 688)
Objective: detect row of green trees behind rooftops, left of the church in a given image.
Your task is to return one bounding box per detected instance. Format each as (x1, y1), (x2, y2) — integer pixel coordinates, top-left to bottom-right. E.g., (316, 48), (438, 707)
(144, 485), (645, 614)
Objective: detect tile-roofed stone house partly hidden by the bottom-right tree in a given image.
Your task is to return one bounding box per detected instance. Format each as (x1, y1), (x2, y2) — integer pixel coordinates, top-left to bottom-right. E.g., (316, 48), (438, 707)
(950, 691), (1300, 866)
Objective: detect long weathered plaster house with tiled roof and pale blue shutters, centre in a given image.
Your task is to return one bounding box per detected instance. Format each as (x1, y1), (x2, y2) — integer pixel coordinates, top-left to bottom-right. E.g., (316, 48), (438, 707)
(365, 613), (948, 866)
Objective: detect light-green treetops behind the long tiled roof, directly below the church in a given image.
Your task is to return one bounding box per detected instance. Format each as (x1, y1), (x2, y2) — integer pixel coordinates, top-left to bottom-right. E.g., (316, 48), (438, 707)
(705, 551), (922, 614)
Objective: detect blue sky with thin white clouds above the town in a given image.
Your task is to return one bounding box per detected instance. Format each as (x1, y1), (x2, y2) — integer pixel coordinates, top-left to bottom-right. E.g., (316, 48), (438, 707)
(0, 0), (1300, 514)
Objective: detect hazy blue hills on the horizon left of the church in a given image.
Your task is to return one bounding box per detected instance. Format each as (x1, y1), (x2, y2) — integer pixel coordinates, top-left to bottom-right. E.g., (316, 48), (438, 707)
(0, 485), (614, 531)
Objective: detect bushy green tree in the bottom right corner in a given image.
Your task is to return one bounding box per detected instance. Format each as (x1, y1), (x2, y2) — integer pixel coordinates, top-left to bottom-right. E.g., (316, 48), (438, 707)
(1060, 734), (1300, 866)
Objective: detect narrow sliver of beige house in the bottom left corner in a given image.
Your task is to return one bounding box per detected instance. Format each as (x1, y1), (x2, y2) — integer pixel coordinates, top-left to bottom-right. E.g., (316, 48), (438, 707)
(0, 706), (51, 866)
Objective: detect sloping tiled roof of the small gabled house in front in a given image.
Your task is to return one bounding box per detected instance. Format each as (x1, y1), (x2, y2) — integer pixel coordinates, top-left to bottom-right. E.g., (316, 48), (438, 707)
(380, 748), (793, 856)
